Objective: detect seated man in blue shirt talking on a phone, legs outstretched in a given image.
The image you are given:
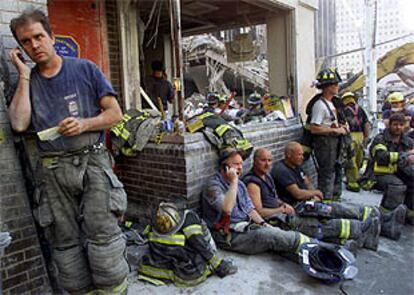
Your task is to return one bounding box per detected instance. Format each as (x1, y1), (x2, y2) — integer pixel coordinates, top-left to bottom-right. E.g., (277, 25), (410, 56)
(201, 148), (310, 260)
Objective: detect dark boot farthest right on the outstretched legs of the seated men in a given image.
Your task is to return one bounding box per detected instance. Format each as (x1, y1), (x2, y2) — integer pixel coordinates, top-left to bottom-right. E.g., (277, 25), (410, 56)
(381, 204), (407, 241)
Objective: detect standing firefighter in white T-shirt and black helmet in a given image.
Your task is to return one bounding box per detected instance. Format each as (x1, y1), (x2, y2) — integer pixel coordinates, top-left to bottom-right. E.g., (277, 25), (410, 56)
(307, 69), (348, 201)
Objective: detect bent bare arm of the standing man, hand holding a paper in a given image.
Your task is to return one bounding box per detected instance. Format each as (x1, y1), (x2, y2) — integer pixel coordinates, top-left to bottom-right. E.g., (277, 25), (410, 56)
(59, 96), (122, 136)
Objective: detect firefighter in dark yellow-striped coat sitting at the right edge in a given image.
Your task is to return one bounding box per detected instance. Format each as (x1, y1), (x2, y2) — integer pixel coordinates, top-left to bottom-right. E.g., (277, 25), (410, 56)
(361, 113), (414, 225)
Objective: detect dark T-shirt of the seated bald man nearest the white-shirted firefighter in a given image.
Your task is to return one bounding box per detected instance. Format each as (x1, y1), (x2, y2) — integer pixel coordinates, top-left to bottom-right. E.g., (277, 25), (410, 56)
(270, 160), (307, 205)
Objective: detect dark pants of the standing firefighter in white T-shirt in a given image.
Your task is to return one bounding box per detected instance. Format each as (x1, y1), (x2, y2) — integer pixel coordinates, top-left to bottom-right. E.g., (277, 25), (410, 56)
(313, 135), (342, 201)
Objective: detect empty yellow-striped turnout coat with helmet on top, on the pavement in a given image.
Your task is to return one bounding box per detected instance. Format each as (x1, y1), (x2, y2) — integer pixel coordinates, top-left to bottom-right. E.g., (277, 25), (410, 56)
(138, 202), (237, 287)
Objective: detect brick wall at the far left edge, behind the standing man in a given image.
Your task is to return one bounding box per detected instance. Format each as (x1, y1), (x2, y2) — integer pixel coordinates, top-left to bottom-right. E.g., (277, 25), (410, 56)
(0, 0), (50, 295)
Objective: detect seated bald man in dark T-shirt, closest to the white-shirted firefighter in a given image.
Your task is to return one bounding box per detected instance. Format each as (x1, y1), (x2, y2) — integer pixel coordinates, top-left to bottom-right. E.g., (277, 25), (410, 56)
(271, 142), (405, 243)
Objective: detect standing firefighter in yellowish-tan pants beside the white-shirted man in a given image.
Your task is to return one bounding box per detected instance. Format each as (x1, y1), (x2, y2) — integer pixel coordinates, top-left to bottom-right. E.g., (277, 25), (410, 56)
(342, 92), (370, 192)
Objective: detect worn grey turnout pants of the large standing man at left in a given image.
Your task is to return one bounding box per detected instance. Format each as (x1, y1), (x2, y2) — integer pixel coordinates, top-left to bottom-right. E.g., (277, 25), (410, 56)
(34, 148), (129, 294)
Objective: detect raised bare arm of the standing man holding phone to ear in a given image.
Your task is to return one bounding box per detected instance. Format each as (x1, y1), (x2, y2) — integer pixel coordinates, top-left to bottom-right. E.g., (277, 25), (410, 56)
(9, 48), (32, 132)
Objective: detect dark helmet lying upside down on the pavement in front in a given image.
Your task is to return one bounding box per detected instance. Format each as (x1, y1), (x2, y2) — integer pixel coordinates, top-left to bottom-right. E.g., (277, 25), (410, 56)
(299, 243), (358, 283)
